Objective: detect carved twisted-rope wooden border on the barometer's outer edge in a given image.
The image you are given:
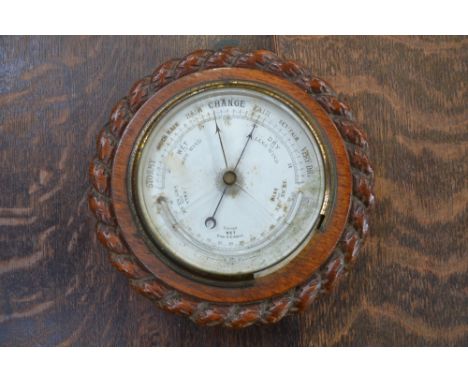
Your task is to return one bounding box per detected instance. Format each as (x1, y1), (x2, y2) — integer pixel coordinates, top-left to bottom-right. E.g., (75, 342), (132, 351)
(88, 48), (374, 328)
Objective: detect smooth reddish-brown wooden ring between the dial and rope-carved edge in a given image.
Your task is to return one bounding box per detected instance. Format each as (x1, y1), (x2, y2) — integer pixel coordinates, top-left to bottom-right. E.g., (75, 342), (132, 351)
(111, 68), (351, 303)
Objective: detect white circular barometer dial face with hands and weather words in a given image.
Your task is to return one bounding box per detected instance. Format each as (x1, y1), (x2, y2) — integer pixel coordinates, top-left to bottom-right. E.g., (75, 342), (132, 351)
(135, 87), (325, 276)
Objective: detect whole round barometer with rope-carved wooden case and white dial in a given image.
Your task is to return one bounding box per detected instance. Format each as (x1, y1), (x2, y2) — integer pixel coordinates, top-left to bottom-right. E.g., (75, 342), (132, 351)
(89, 48), (374, 328)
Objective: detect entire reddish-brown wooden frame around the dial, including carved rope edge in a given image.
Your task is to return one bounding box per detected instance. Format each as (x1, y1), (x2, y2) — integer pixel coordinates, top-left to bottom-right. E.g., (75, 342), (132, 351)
(89, 49), (374, 327)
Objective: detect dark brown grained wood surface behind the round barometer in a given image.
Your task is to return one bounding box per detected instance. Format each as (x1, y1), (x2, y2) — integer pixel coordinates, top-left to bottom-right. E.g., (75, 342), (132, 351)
(0, 36), (468, 346)
